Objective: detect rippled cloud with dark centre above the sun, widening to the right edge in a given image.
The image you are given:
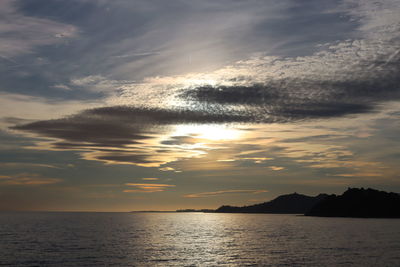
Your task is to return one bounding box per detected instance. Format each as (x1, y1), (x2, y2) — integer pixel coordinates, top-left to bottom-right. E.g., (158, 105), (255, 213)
(179, 27), (400, 122)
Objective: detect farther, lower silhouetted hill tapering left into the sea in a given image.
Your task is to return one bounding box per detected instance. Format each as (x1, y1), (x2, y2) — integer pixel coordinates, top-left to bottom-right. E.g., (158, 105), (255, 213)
(215, 193), (327, 214)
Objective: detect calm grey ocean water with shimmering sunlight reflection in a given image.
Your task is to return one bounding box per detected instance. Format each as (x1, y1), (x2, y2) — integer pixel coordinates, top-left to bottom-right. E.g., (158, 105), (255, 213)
(0, 212), (400, 266)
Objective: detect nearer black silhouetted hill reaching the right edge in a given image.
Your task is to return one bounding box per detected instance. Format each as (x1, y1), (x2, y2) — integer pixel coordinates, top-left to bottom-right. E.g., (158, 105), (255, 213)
(305, 188), (400, 218)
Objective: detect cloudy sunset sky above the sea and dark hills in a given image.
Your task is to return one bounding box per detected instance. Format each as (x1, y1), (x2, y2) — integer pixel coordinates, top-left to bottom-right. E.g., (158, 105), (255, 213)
(0, 0), (400, 211)
